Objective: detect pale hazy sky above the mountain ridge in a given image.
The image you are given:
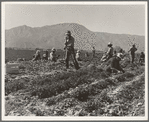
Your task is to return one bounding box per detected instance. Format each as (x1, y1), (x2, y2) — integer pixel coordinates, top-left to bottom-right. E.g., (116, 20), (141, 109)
(5, 4), (145, 35)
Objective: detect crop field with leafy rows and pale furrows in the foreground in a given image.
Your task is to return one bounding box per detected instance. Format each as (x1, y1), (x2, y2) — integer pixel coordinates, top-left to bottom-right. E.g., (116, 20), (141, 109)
(5, 51), (145, 116)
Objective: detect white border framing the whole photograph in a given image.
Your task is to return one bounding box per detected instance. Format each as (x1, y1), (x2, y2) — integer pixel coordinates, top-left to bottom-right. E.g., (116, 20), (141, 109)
(1, 1), (148, 121)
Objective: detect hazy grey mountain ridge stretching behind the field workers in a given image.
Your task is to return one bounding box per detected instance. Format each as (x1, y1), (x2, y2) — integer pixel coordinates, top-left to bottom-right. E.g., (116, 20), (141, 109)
(5, 23), (145, 51)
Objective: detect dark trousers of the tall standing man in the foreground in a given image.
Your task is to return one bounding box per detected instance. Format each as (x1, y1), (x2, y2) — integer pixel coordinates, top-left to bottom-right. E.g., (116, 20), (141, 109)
(65, 47), (79, 70)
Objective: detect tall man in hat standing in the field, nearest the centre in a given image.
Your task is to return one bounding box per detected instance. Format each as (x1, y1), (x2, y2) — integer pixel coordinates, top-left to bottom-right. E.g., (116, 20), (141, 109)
(64, 31), (79, 70)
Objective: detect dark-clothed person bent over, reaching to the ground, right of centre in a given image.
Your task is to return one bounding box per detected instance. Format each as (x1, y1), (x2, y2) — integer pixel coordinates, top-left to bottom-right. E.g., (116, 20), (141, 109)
(106, 53), (125, 73)
